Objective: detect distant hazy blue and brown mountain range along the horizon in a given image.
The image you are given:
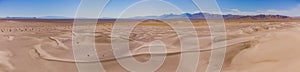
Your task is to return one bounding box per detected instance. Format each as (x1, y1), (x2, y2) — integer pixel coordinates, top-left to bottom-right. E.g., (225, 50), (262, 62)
(1, 12), (299, 20)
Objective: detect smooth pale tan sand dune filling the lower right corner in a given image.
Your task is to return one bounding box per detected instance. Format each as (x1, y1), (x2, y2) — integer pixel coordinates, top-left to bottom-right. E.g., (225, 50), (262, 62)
(227, 29), (300, 72)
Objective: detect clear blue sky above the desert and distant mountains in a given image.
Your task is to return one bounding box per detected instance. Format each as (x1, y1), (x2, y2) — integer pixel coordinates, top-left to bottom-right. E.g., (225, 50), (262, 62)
(0, 0), (300, 18)
